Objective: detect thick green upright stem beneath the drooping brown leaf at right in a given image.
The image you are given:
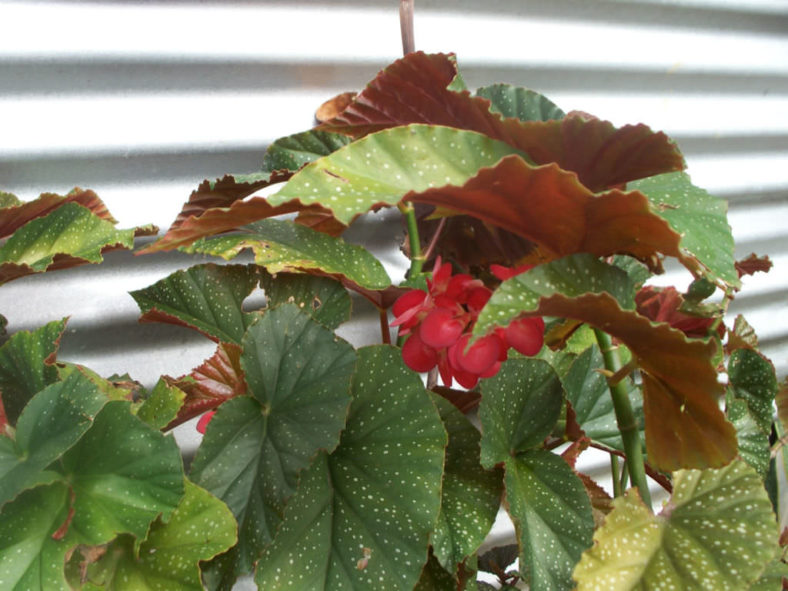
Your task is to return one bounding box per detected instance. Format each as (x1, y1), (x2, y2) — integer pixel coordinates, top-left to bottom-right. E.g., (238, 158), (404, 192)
(594, 328), (651, 508)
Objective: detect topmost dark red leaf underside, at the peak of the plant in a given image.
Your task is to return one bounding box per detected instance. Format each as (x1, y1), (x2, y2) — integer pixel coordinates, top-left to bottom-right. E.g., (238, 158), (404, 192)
(320, 52), (684, 191)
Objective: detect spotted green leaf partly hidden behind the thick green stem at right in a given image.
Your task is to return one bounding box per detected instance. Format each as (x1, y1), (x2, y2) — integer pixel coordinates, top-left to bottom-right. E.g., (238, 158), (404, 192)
(563, 346), (645, 451)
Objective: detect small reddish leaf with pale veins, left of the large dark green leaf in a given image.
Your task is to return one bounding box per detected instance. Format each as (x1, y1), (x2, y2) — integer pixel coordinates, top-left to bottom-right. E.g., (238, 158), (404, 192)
(166, 343), (247, 429)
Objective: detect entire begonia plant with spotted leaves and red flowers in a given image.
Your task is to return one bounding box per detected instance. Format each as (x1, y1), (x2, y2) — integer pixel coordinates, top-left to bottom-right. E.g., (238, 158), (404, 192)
(0, 53), (788, 591)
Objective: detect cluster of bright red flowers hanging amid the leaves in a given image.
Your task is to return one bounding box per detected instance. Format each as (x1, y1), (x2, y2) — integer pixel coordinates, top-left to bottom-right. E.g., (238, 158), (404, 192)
(392, 258), (544, 389)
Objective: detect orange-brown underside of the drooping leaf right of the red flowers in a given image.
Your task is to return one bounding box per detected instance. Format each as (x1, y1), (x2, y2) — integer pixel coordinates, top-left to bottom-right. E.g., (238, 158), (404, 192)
(508, 293), (737, 472)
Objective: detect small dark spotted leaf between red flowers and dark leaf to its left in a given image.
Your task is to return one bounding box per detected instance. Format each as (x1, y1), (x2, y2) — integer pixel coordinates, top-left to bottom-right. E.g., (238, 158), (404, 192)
(261, 273), (351, 329)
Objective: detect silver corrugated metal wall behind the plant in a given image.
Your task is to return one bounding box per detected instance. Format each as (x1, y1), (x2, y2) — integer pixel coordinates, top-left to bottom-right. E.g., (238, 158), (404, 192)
(0, 0), (788, 588)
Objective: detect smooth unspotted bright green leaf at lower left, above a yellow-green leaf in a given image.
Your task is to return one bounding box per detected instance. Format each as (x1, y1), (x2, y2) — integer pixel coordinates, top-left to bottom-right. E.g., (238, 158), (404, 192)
(62, 401), (183, 544)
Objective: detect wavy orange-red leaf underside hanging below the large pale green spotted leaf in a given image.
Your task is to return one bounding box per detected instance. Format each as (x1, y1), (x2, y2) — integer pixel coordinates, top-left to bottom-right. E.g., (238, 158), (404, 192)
(405, 156), (681, 271)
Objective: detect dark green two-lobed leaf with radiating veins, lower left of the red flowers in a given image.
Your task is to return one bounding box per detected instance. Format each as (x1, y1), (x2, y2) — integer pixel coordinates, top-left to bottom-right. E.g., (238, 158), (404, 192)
(191, 304), (356, 583)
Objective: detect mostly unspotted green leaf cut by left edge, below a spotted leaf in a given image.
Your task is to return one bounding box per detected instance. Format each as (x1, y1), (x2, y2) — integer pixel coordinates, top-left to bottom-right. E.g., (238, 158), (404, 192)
(0, 372), (107, 506)
